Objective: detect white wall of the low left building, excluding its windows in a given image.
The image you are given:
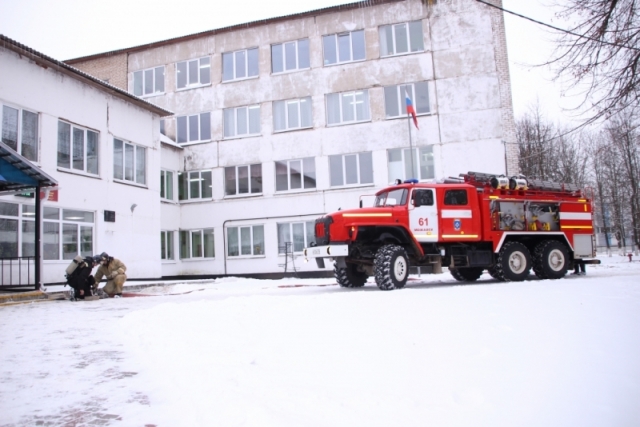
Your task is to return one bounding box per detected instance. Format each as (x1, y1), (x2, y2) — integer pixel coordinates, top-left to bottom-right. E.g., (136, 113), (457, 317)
(0, 48), (161, 283)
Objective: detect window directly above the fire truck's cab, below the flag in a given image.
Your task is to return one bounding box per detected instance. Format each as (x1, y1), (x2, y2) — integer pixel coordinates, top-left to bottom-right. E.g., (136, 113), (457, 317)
(387, 146), (435, 182)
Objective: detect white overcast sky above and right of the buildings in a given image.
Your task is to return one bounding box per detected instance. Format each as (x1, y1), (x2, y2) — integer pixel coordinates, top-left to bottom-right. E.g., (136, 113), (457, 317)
(0, 0), (575, 122)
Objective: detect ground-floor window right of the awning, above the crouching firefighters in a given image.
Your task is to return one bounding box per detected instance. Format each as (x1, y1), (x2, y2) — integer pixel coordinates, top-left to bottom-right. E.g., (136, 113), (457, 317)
(39, 206), (94, 260)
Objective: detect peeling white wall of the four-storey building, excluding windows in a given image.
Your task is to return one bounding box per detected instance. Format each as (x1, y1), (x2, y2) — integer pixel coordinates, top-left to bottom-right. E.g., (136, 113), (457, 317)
(67, 0), (517, 275)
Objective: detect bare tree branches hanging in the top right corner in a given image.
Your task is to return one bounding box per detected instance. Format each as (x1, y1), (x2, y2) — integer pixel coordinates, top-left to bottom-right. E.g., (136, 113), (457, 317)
(549, 0), (640, 122)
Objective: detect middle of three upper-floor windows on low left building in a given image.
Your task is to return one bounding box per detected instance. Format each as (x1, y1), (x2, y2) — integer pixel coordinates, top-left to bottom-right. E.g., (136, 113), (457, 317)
(58, 121), (98, 175)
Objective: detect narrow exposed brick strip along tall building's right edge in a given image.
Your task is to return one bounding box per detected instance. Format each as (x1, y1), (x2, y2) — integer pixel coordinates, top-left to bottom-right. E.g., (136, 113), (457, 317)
(486, 0), (520, 176)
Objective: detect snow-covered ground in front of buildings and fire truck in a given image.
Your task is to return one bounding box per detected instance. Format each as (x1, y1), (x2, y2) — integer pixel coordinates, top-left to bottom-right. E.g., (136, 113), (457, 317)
(0, 256), (640, 427)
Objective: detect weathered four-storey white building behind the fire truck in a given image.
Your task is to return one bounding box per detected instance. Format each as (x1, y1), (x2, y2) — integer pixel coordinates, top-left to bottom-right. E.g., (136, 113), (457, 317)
(66, 0), (517, 276)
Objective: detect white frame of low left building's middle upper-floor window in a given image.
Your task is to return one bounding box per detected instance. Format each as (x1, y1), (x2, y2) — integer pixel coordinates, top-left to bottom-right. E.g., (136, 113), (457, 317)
(56, 120), (100, 176)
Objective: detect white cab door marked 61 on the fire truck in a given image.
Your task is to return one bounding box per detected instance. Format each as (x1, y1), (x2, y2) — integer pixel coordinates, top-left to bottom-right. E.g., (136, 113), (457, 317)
(409, 188), (438, 242)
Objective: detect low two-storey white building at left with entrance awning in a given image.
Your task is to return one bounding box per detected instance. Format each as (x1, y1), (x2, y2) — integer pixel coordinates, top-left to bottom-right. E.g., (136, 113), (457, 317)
(0, 35), (172, 285)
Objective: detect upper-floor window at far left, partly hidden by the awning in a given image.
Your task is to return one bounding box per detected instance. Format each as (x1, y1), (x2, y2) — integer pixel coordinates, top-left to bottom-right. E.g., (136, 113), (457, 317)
(0, 104), (38, 162)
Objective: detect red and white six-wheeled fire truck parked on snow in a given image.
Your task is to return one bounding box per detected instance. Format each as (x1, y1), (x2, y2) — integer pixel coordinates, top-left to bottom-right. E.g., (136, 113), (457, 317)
(304, 172), (600, 290)
